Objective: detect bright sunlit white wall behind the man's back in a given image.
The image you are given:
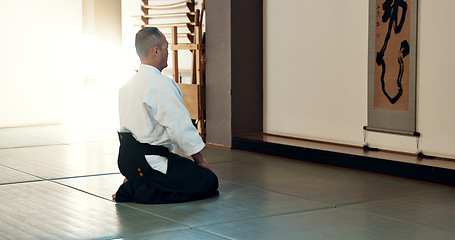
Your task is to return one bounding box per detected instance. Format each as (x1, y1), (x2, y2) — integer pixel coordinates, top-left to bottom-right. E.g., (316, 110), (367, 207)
(0, 0), (127, 127)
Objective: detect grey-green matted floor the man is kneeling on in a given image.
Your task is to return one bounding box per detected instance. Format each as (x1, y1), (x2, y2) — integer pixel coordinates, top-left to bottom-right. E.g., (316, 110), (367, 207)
(0, 125), (455, 240)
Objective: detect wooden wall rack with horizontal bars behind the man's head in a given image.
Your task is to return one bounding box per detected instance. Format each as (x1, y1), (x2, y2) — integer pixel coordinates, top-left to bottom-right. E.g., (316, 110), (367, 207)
(136, 0), (206, 141)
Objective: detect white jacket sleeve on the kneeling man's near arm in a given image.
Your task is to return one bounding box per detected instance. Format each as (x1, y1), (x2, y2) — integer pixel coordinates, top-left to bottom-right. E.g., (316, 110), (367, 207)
(144, 77), (205, 156)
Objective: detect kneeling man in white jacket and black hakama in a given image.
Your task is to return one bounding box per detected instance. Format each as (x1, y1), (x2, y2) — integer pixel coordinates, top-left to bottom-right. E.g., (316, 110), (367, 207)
(112, 27), (218, 204)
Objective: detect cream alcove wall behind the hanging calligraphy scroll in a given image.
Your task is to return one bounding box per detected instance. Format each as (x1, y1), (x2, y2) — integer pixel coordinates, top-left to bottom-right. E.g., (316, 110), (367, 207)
(264, 0), (455, 158)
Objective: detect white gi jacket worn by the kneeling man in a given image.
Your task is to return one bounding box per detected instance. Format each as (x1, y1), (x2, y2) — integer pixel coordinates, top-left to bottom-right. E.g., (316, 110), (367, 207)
(119, 64), (205, 173)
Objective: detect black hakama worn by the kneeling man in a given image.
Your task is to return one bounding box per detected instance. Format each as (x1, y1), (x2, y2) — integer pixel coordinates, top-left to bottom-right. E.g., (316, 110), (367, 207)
(115, 132), (219, 204)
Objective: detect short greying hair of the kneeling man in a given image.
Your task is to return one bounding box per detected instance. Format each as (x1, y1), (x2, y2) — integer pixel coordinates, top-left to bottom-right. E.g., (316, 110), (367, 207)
(135, 27), (163, 59)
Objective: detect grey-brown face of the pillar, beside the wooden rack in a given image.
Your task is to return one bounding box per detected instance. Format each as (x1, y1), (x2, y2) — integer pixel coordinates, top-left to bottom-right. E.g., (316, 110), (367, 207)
(206, 0), (232, 146)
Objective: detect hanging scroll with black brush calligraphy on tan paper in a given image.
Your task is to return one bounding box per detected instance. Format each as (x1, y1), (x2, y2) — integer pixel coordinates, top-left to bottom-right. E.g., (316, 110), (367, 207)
(367, 0), (417, 134)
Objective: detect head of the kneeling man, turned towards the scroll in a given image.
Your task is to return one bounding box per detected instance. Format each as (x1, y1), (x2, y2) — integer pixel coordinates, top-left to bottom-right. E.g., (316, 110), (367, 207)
(136, 27), (169, 71)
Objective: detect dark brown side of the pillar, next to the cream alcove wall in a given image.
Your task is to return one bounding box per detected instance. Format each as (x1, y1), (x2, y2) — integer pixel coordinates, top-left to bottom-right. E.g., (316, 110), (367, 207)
(231, 0), (263, 136)
